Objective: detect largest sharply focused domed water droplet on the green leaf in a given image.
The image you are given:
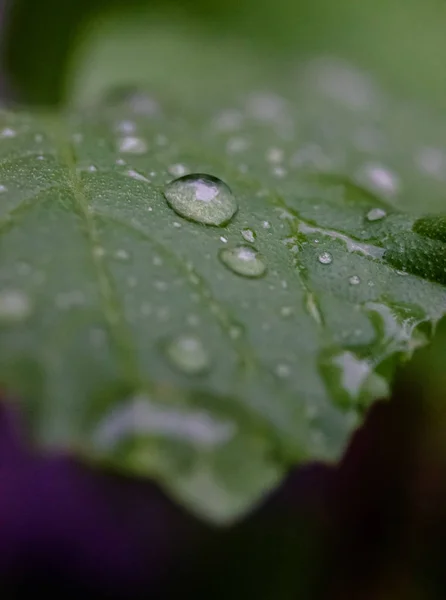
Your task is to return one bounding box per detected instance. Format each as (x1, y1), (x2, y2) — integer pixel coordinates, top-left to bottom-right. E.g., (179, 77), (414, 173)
(164, 173), (237, 225)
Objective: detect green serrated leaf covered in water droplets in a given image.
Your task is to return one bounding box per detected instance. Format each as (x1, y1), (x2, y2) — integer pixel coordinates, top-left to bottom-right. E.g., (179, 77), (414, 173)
(0, 30), (446, 522)
